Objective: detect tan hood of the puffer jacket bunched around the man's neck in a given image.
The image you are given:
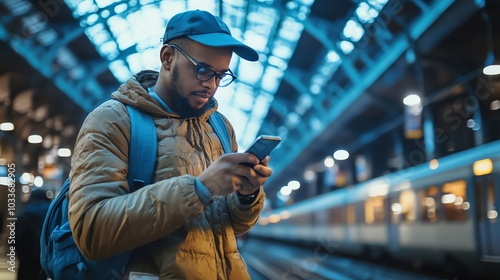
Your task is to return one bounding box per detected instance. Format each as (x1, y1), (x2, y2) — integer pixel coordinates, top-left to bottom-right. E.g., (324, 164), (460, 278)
(111, 70), (218, 118)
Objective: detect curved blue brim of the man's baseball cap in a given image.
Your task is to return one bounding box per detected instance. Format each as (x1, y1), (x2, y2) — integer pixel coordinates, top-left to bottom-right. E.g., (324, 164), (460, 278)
(187, 33), (259, 61)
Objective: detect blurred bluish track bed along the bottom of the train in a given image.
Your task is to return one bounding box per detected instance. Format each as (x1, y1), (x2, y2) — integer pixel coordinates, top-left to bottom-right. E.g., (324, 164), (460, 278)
(240, 239), (456, 280)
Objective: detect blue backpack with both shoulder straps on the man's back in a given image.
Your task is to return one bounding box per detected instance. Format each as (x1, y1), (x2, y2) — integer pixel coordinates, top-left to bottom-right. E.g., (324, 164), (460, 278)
(40, 106), (232, 280)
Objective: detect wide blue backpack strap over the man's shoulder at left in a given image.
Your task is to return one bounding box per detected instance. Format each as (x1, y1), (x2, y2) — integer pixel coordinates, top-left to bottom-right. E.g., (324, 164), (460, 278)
(126, 105), (157, 192)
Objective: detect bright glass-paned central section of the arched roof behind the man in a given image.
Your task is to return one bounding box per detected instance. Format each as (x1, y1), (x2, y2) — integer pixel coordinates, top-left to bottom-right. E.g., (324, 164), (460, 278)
(61, 0), (314, 150)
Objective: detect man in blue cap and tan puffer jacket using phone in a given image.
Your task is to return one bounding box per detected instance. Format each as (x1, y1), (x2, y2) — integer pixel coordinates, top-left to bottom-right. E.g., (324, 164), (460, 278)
(69, 10), (272, 279)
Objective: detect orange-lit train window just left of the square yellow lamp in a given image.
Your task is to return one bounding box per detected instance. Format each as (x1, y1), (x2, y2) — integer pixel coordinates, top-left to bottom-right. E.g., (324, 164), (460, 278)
(441, 180), (469, 221)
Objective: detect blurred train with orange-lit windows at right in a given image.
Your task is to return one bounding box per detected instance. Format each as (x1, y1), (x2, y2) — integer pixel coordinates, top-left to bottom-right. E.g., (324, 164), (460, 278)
(248, 140), (500, 279)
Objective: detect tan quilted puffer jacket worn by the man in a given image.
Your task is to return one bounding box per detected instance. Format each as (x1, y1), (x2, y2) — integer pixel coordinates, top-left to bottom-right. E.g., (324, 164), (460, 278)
(69, 73), (265, 280)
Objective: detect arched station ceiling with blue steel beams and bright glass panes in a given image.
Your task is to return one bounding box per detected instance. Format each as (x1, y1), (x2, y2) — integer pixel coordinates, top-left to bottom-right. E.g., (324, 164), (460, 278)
(0, 0), (500, 197)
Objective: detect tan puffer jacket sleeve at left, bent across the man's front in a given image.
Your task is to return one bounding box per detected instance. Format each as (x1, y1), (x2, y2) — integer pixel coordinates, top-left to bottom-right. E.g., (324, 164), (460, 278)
(69, 101), (203, 260)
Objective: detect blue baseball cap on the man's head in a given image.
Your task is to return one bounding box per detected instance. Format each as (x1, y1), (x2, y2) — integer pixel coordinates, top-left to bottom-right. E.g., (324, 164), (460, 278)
(163, 10), (259, 61)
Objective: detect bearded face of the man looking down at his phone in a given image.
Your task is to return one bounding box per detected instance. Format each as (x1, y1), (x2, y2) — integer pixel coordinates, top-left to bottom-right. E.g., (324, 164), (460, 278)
(166, 42), (232, 117)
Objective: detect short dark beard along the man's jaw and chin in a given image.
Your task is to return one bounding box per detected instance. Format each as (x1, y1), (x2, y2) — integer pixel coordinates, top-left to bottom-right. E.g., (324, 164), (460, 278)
(169, 67), (214, 118)
